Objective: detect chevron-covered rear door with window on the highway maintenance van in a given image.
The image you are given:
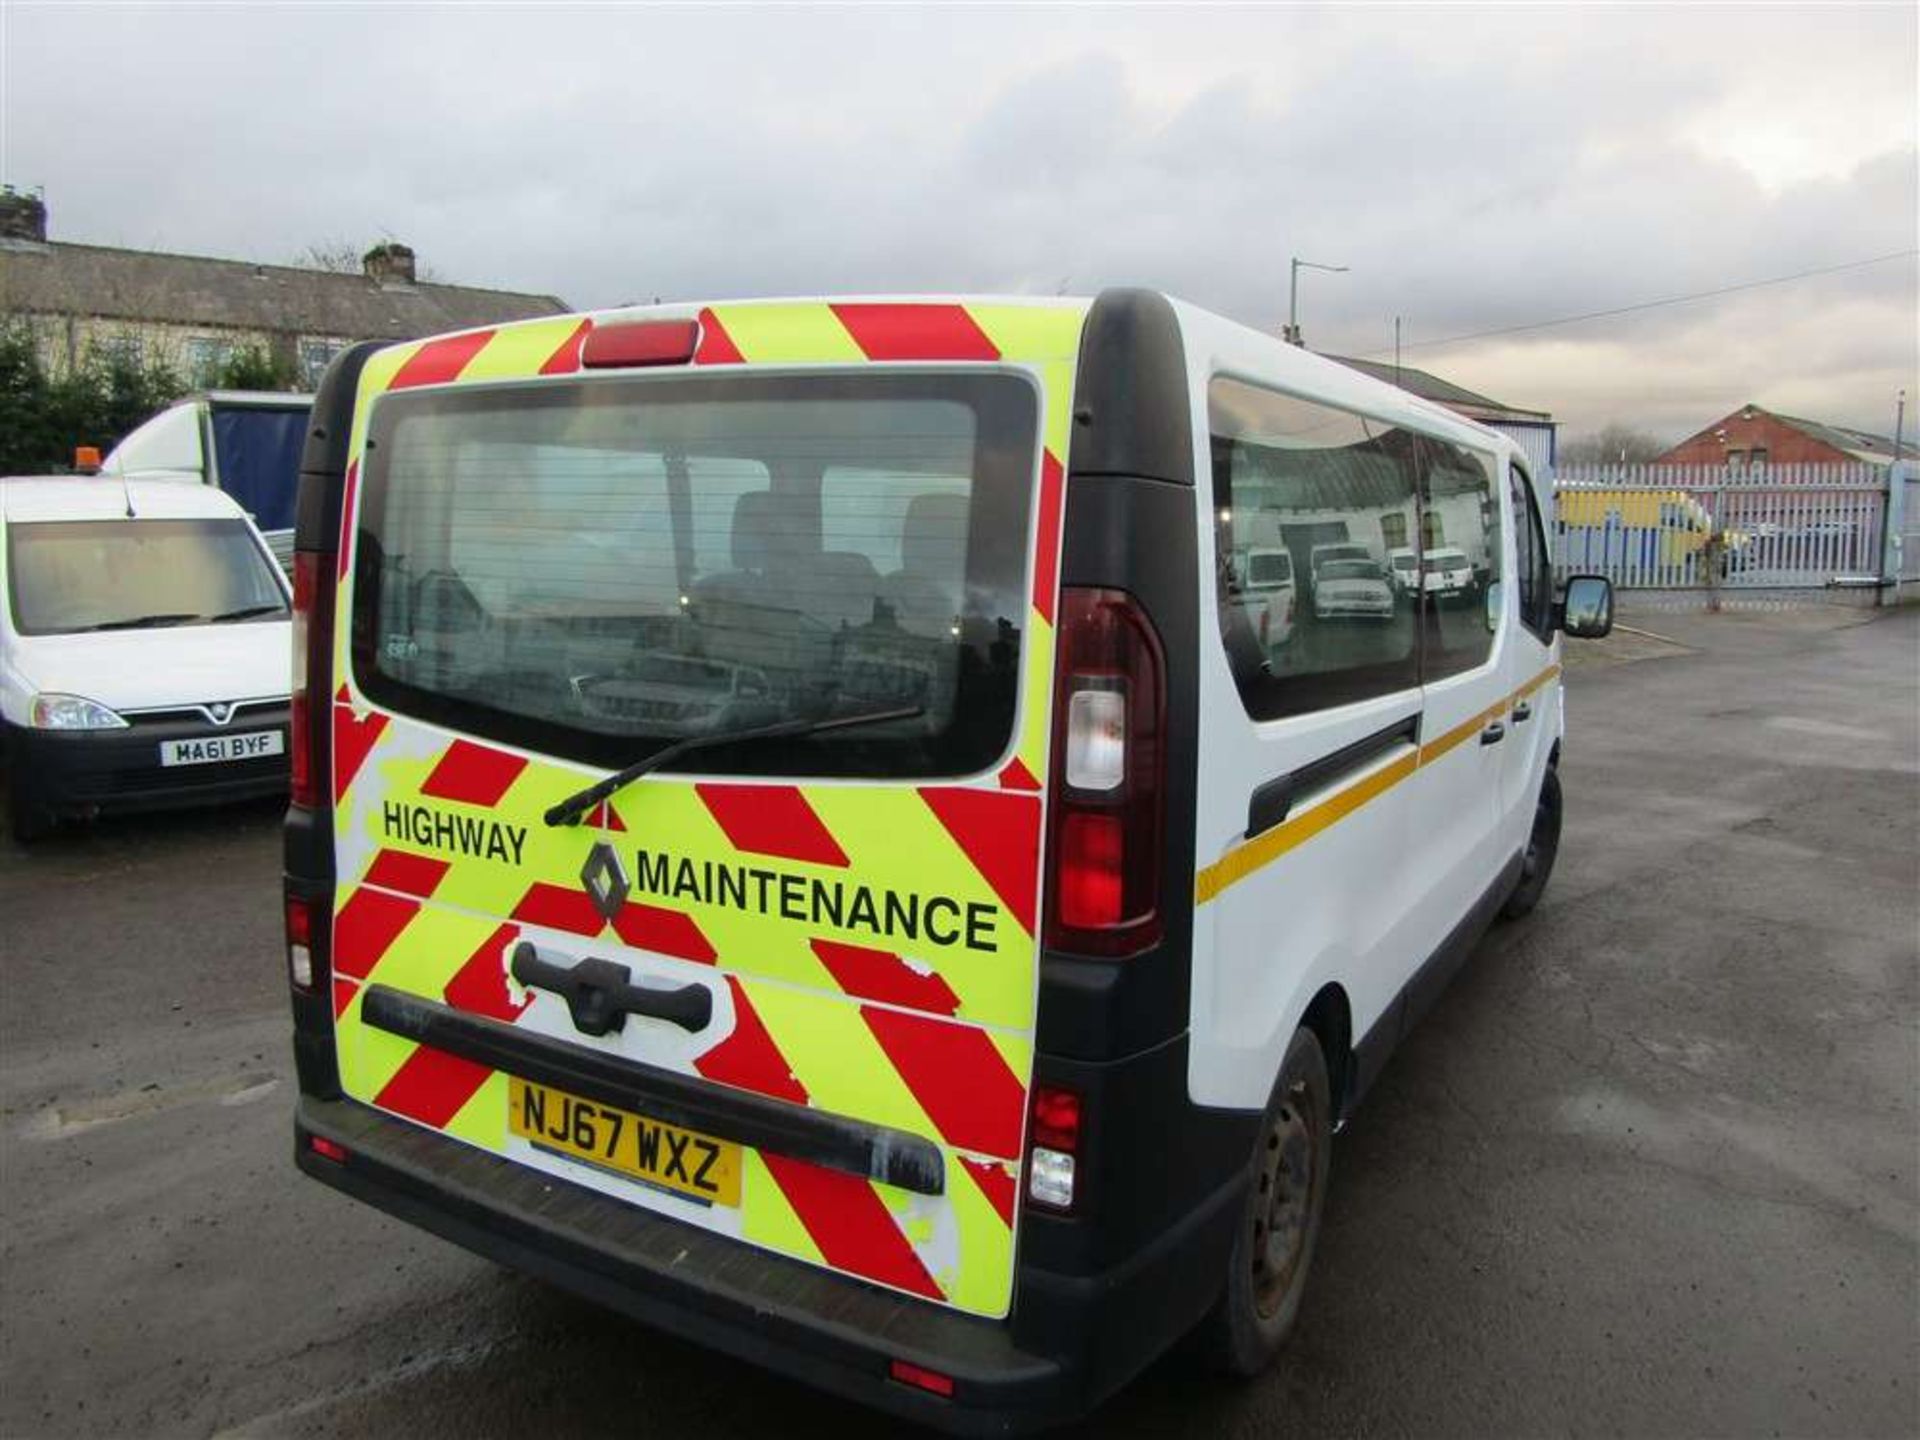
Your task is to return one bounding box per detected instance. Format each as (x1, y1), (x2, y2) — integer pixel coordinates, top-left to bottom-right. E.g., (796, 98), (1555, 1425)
(332, 307), (1081, 1315)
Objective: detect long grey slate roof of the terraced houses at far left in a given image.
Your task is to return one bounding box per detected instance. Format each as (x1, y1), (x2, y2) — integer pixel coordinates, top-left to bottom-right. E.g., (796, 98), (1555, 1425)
(0, 242), (566, 340)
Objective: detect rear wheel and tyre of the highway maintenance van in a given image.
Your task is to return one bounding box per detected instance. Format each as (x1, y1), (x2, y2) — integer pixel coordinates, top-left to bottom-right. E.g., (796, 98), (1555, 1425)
(1202, 1029), (1332, 1377)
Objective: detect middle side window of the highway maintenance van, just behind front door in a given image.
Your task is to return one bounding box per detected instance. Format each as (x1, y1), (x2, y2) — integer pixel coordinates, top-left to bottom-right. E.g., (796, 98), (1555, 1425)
(1419, 436), (1500, 680)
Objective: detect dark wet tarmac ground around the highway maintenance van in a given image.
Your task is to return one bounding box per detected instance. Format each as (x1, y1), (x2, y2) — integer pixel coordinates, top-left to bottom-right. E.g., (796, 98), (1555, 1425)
(0, 607), (1920, 1440)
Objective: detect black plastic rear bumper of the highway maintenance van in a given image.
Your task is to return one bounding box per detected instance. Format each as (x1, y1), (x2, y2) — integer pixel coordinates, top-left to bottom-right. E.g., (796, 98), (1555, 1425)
(296, 1094), (1242, 1434)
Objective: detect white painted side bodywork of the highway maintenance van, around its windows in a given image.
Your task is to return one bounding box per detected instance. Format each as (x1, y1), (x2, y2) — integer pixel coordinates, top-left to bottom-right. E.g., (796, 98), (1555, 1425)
(1175, 303), (1561, 1110)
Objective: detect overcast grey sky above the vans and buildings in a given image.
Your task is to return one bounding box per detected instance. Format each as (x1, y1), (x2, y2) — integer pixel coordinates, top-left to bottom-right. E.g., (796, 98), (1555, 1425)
(0, 0), (1920, 438)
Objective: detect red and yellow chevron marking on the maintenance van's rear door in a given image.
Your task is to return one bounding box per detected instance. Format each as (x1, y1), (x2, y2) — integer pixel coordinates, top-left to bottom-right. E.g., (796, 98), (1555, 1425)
(332, 301), (1085, 1315)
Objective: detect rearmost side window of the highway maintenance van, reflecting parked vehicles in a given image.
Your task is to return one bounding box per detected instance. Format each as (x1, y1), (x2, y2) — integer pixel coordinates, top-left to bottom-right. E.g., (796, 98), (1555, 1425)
(1208, 376), (1419, 720)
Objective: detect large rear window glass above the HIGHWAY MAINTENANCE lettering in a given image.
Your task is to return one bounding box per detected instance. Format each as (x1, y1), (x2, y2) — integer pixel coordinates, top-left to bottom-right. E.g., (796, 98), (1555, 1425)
(353, 371), (1039, 778)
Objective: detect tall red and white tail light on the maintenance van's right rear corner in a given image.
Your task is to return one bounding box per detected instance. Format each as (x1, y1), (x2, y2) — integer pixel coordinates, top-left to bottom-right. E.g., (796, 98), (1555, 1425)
(1046, 586), (1165, 956)
